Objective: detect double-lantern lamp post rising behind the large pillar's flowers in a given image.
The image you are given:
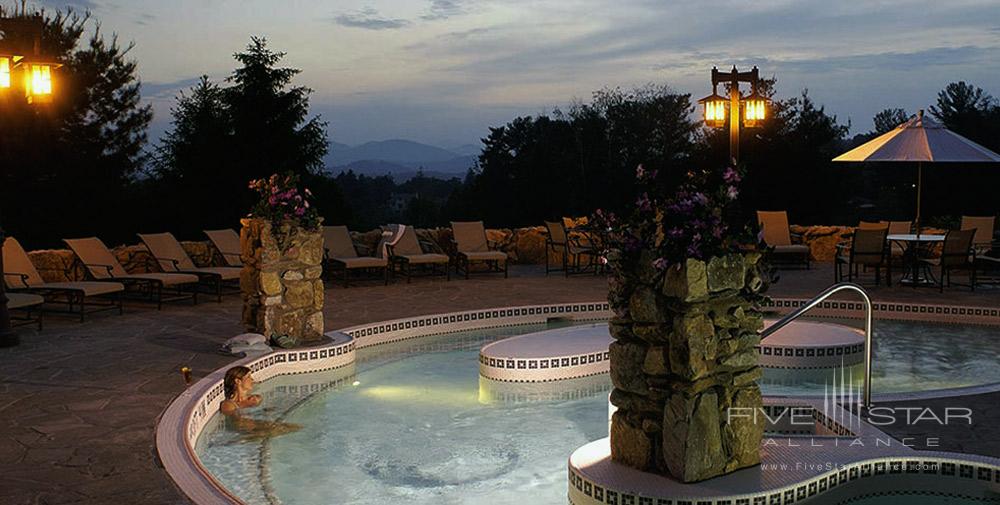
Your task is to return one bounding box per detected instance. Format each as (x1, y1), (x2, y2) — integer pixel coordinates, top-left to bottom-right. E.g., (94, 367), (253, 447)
(698, 65), (767, 165)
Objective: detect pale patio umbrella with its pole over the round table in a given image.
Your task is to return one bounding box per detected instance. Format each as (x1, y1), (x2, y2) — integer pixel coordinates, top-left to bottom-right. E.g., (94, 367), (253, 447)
(833, 110), (1000, 235)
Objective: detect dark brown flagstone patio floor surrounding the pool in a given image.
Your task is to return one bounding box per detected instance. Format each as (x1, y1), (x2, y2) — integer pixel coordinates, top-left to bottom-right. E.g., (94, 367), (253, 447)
(0, 265), (1000, 505)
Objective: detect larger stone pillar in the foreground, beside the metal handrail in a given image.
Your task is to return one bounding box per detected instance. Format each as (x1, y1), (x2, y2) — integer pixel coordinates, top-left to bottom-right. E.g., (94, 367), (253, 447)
(609, 253), (767, 482)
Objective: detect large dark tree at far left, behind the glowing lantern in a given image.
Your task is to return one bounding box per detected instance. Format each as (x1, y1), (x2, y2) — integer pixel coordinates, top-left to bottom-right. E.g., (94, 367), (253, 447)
(0, 9), (152, 247)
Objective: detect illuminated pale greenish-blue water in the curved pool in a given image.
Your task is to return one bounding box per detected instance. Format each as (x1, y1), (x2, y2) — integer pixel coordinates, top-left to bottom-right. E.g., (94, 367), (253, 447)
(196, 321), (1000, 505)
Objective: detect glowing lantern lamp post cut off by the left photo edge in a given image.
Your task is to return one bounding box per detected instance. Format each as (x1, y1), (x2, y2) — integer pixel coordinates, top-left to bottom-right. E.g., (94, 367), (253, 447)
(0, 16), (61, 347)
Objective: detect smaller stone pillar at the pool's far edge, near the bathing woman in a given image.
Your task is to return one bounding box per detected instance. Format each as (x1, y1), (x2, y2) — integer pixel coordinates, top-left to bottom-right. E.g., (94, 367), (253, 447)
(240, 218), (323, 342)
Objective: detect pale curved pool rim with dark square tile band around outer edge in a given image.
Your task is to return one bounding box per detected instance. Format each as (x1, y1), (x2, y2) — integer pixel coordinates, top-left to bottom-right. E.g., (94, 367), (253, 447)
(154, 298), (1000, 505)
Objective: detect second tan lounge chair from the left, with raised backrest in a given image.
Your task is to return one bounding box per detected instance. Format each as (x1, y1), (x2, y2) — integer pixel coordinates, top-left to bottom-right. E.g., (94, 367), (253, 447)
(63, 237), (198, 310)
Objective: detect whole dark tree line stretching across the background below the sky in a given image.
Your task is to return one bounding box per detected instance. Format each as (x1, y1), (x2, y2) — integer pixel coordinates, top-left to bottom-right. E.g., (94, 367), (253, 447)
(0, 10), (1000, 247)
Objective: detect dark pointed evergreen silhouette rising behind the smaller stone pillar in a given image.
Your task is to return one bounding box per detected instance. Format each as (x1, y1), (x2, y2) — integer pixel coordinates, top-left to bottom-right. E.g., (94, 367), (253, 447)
(155, 37), (338, 232)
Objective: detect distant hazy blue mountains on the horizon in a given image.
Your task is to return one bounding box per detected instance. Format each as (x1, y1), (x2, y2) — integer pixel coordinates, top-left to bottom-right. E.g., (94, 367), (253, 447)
(325, 139), (479, 182)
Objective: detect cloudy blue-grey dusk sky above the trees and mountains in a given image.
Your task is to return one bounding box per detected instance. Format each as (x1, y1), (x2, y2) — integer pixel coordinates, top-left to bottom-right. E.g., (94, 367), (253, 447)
(37, 0), (1000, 147)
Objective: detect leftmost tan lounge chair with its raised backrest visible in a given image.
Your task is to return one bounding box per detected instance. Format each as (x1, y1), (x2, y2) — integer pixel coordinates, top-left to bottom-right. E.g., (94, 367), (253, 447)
(3, 237), (125, 322)
